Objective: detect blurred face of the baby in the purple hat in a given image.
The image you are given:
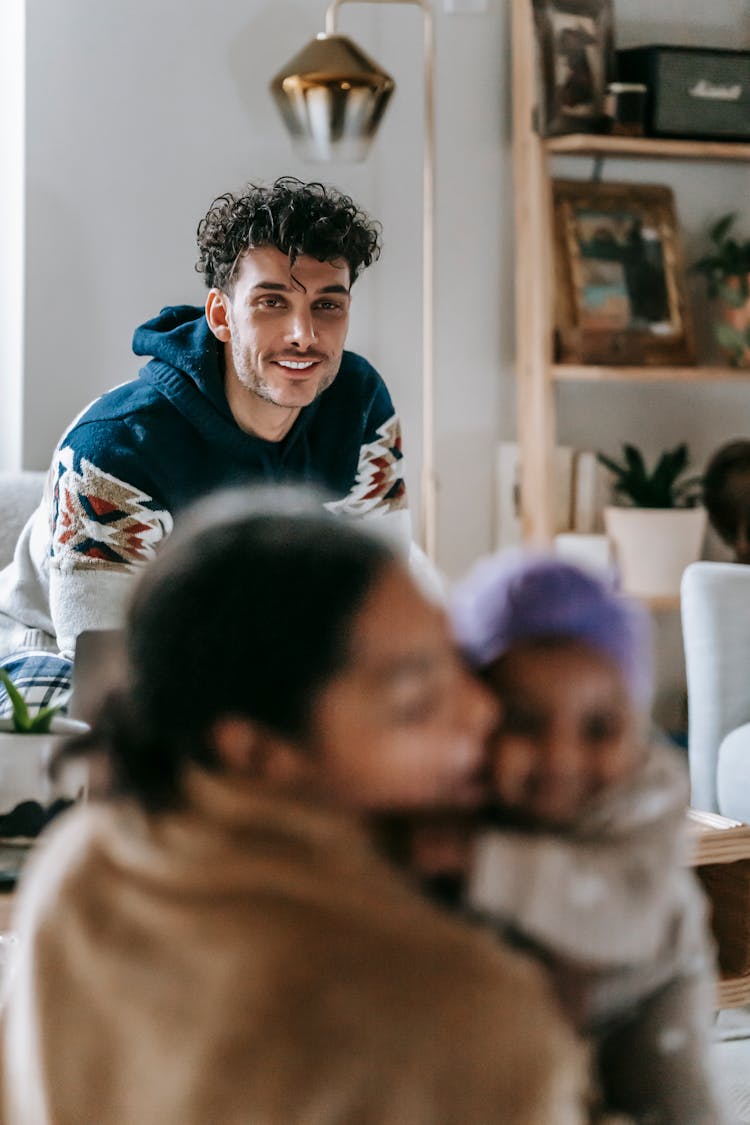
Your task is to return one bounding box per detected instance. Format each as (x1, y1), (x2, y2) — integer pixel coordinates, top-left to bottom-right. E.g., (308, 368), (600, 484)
(488, 641), (643, 826)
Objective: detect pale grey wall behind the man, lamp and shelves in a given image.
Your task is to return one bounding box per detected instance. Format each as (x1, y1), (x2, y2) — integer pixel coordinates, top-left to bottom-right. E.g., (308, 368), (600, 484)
(8, 0), (750, 574)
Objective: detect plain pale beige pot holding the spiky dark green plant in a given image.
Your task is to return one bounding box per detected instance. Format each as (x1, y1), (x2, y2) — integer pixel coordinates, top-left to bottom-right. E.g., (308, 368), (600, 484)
(604, 507), (706, 597)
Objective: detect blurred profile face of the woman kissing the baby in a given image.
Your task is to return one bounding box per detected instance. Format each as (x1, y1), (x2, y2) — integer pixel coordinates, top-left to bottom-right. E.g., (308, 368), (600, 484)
(309, 565), (497, 812)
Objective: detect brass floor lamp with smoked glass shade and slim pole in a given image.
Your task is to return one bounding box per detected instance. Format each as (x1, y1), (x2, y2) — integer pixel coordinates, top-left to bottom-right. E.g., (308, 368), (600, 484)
(271, 0), (437, 560)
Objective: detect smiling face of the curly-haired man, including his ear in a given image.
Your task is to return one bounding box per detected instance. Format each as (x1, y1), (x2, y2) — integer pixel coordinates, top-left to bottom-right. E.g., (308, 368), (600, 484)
(207, 246), (350, 408)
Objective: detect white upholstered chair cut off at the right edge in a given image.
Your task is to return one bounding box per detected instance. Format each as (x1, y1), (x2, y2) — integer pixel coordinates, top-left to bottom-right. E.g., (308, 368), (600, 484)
(681, 563), (750, 821)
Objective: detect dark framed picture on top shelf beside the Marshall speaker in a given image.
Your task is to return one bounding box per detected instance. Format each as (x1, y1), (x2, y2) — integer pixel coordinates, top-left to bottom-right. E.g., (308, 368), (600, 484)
(533, 0), (615, 136)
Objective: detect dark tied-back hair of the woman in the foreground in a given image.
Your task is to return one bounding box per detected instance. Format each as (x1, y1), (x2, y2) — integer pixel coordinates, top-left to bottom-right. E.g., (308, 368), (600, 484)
(64, 488), (394, 809)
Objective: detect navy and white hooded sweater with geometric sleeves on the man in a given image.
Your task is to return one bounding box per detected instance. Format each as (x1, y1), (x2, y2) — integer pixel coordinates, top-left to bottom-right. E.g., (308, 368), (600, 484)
(0, 305), (410, 658)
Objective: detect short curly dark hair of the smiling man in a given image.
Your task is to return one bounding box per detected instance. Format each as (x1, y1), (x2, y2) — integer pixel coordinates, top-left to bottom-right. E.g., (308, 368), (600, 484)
(196, 176), (380, 293)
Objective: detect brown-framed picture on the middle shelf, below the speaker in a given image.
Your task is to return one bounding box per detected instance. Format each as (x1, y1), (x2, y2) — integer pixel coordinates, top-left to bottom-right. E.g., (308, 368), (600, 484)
(552, 180), (695, 366)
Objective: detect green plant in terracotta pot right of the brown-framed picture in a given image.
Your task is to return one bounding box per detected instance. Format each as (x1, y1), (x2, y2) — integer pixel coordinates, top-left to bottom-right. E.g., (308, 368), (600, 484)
(692, 213), (750, 367)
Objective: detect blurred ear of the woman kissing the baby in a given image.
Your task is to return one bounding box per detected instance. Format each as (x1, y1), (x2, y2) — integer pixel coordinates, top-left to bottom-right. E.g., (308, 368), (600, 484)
(210, 716), (311, 789)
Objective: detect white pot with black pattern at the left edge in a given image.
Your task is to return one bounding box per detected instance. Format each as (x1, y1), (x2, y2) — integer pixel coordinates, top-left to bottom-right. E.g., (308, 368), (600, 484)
(0, 716), (89, 882)
